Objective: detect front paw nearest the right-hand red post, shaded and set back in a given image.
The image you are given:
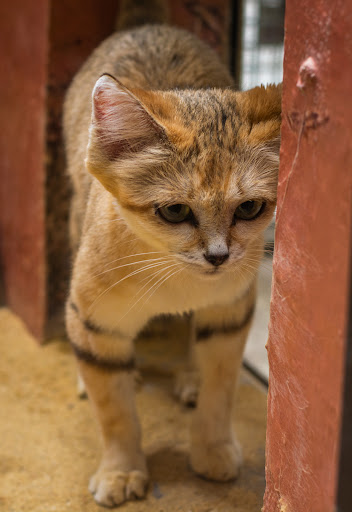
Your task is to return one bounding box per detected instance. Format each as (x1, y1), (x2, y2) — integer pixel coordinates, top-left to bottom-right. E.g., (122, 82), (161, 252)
(191, 441), (242, 482)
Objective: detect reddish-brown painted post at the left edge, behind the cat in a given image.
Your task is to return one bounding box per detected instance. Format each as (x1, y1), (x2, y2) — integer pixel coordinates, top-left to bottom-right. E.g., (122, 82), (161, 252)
(0, 0), (49, 337)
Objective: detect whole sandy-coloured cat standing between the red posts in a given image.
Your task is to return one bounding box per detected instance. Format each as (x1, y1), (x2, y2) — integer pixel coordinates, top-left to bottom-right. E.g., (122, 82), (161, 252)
(64, 1), (281, 506)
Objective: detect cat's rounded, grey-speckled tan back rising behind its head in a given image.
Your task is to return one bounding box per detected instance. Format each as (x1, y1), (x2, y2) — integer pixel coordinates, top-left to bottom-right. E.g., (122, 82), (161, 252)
(68, 24), (233, 101)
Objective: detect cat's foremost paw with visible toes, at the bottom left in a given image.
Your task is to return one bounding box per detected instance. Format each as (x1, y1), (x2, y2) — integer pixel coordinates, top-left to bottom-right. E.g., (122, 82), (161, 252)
(89, 469), (148, 507)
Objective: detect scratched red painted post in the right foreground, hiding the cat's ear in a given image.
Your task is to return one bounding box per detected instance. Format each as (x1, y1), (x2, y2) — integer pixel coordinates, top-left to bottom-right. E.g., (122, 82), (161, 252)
(263, 0), (352, 512)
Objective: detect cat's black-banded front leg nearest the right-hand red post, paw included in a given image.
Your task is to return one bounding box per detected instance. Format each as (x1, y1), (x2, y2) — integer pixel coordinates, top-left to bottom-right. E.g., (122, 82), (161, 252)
(191, 287), (255, 481)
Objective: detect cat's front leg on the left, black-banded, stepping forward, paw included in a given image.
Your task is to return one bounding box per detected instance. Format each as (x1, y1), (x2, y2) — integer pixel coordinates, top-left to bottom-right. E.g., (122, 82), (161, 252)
(67, 304), (148, 507)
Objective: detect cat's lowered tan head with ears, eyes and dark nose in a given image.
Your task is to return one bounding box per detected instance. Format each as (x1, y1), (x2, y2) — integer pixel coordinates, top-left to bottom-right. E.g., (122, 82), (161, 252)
(86, 75), (281, 273)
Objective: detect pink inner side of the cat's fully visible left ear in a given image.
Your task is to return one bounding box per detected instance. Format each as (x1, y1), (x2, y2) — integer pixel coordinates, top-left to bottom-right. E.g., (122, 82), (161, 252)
(93, 76), (162, 159)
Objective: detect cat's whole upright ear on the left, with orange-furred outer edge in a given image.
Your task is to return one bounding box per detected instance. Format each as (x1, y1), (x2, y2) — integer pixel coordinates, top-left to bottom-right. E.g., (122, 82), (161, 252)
(86, 75), (167, 190)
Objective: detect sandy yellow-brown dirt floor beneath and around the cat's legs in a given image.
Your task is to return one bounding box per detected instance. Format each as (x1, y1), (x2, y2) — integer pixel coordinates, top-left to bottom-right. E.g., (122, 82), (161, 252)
(0, 309), (266, 512)
